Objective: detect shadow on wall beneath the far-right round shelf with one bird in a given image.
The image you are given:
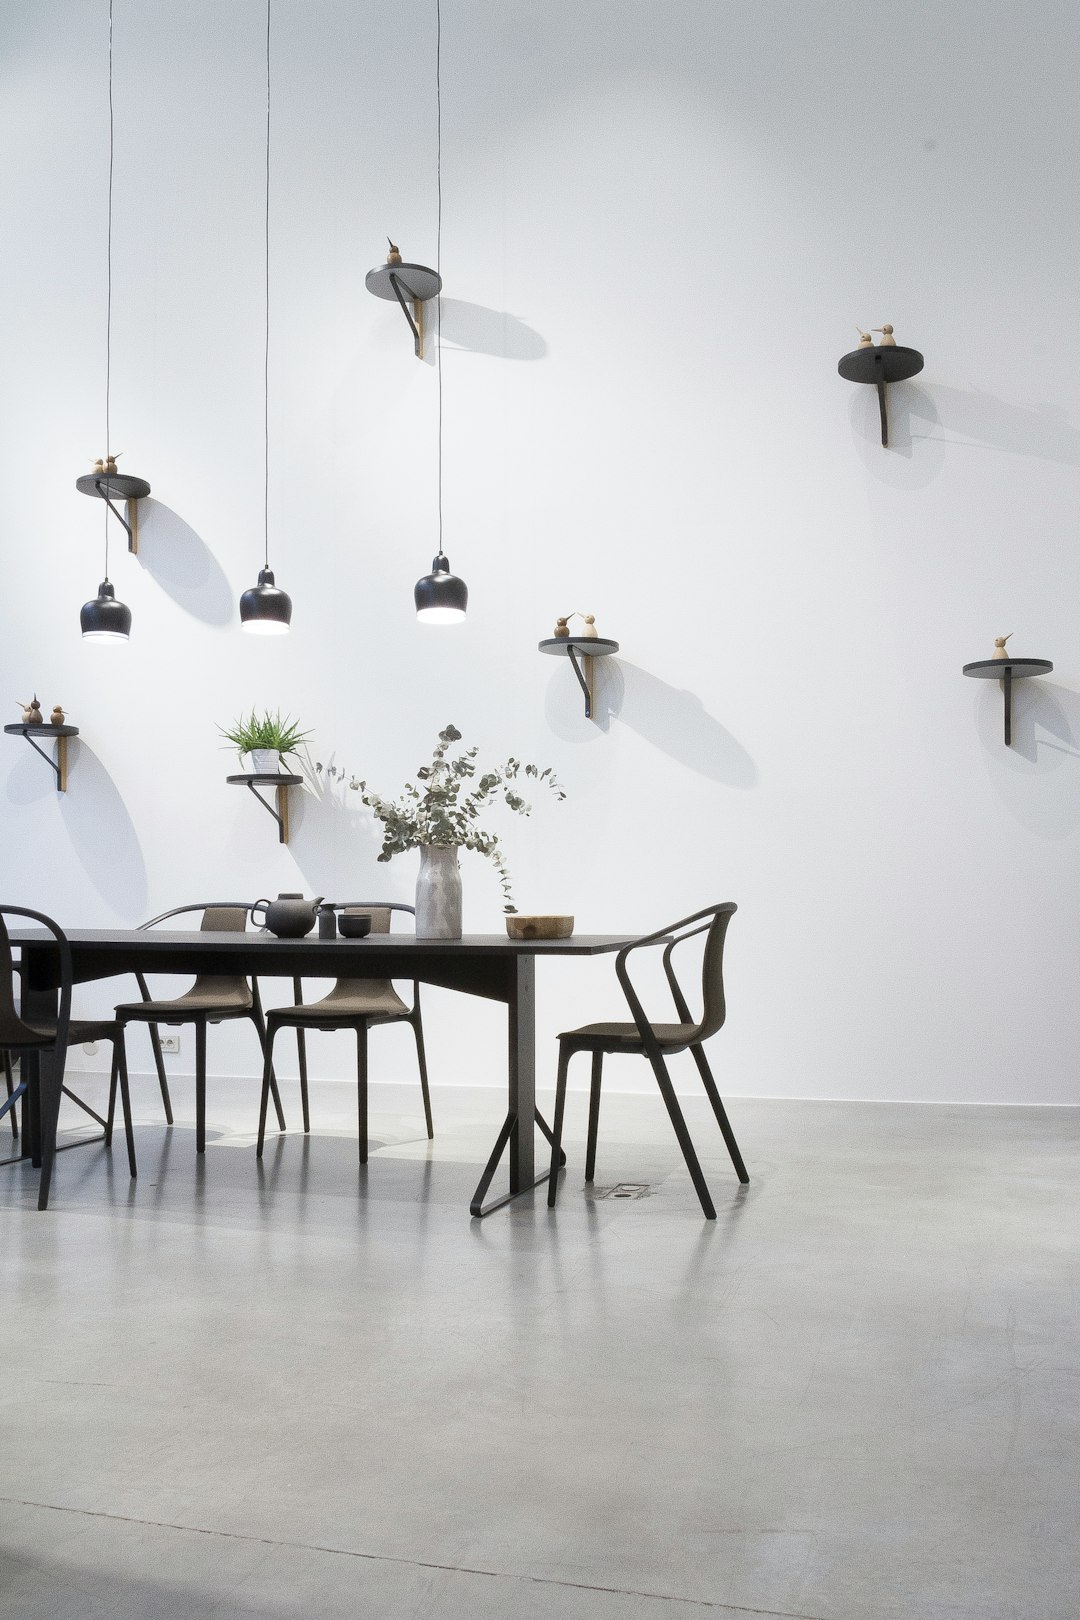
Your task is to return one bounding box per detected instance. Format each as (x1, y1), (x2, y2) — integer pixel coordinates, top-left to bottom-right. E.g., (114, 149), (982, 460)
(975, 679), (1080, 839)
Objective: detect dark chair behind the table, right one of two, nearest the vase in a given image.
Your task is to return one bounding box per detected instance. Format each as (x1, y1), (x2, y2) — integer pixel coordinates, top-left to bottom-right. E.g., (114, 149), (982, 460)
(256, 901), (436, 1165)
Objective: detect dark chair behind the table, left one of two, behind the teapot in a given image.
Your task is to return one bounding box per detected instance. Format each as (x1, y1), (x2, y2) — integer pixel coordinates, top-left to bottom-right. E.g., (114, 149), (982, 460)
(108, 901), (285, 1153)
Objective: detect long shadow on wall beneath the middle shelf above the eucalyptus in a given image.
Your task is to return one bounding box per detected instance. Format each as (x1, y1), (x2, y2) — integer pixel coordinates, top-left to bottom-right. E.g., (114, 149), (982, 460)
(546, 658), (758, 787)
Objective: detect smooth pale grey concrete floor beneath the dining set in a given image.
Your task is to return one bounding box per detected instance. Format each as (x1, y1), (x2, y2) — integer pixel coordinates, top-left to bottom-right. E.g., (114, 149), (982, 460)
(0, 1082), (1080, 1620)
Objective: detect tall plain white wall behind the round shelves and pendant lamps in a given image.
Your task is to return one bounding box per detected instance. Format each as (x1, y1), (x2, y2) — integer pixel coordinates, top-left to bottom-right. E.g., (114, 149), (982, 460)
(0, 0), (1080, 1102)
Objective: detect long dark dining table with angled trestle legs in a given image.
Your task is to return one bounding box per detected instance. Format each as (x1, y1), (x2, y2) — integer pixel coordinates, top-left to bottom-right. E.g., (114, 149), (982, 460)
(11, 928), (633, 1215)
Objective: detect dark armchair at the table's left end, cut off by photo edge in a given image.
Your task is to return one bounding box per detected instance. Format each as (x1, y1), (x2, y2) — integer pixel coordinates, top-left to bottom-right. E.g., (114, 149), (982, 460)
(0, 906), (138, 1210)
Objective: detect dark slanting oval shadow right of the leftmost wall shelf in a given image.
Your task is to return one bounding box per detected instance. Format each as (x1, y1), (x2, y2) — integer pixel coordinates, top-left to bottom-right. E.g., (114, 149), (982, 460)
(60, 737), (149, 922)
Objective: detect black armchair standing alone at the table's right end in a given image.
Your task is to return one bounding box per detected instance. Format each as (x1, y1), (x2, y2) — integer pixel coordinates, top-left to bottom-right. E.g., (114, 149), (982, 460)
(547, 901), (750, 1220)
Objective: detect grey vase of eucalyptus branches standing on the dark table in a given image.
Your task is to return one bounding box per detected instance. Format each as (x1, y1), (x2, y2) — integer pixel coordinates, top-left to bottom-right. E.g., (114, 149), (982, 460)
(348, 726), (567, 940)
